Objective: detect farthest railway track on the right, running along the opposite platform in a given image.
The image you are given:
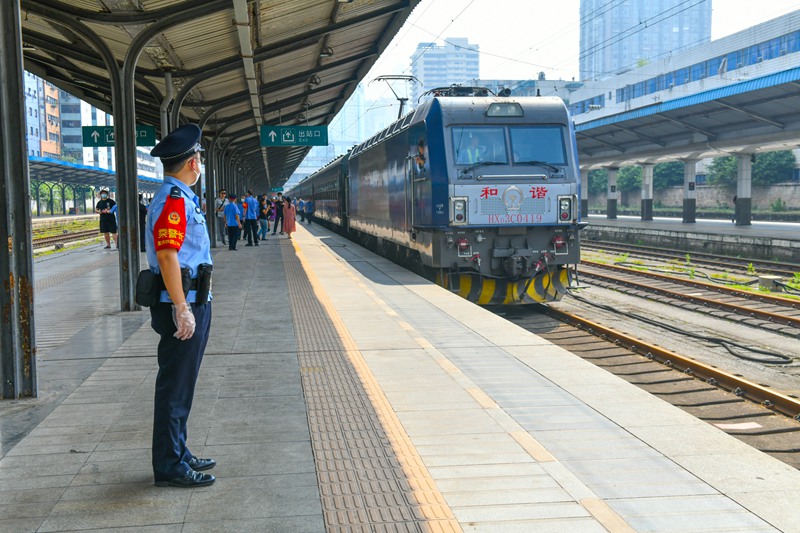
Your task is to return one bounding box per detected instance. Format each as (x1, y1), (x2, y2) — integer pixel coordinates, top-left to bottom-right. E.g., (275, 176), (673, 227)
(581, 240), (800, 278)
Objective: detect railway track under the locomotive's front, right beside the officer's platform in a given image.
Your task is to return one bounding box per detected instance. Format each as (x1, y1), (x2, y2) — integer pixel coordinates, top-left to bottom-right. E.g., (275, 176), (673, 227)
(492, 306), (800, 468)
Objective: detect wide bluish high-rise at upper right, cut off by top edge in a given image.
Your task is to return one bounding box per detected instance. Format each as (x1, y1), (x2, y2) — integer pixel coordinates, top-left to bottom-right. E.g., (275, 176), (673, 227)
(579, 0), (711, 80)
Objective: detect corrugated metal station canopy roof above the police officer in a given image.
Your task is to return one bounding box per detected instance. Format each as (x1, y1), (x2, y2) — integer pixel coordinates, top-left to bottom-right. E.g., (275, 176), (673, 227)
(21, 0), (419, 189)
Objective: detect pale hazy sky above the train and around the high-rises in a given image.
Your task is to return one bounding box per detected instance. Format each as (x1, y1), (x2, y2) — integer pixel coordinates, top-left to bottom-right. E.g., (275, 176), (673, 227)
(364, 0), (800, 98)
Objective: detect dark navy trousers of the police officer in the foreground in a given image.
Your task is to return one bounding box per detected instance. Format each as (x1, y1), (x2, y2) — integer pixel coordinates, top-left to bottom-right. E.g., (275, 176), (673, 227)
(150, 303), (211, 481)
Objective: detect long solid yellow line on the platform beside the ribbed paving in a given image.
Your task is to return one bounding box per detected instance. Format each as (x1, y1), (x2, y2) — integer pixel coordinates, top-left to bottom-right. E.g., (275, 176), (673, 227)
(292, 240), (463, 532)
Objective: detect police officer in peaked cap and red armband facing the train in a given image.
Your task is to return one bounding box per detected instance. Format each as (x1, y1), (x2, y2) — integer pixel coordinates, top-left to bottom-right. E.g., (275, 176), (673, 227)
(146, 124), (216, 487)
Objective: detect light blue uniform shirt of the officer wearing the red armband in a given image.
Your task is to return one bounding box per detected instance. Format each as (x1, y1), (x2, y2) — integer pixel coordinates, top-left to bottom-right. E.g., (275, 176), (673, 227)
(145, 176), (212, 301)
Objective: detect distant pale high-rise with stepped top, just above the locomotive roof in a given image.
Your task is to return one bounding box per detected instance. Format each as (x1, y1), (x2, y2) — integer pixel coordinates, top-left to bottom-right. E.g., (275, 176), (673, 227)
(409, 37), (480, 104)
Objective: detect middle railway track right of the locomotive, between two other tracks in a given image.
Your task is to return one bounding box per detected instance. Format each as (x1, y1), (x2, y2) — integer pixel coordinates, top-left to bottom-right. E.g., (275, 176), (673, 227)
(580, 261), (800, 337)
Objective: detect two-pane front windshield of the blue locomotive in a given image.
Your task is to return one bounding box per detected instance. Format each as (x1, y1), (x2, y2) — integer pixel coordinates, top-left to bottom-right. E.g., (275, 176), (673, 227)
(452, 126), (567, 166)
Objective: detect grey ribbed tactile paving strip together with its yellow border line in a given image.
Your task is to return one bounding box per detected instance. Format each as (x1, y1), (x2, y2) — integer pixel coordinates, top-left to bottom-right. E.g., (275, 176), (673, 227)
(281, 243), (461, 532)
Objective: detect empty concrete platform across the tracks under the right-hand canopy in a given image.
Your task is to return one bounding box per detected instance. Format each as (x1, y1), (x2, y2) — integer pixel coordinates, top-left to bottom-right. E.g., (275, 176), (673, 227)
(581, 215), (800, 263)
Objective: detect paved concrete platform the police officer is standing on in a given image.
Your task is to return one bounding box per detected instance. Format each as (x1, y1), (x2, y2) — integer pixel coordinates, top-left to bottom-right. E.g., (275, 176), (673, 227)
(0, 225), (800, 532)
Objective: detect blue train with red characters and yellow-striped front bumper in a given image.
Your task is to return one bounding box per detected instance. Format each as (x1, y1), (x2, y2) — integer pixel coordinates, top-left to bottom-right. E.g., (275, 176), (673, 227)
(288, 86), (584, 305)
